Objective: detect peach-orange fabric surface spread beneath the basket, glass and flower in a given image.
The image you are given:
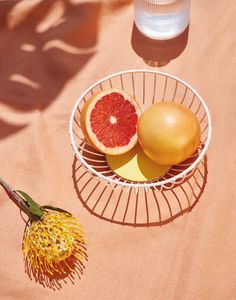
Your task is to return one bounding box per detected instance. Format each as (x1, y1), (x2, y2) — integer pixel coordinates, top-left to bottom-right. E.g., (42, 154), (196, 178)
(0, 0), (236, 300)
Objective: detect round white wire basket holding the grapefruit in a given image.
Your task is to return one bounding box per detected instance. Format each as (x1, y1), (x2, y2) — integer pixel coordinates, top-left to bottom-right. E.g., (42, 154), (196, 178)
(69, 70), (212, 193)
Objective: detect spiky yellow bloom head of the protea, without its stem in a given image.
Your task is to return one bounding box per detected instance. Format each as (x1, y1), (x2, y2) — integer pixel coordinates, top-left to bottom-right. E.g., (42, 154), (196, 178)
(22, 210), (87, 277)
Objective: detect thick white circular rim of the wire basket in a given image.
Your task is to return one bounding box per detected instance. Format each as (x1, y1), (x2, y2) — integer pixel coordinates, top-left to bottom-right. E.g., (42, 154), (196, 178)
(69, 69), (212, 188)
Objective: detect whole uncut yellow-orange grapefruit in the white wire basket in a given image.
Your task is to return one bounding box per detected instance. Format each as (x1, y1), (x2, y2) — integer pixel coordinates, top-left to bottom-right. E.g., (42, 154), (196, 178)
(138, 101), (200, 165)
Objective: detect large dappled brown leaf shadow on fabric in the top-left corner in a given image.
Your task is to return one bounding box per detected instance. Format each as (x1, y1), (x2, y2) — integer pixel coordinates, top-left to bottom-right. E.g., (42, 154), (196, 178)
(0, 1), (101, 138)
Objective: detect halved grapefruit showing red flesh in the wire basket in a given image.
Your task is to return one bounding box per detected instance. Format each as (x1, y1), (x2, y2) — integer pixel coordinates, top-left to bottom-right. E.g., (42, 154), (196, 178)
(80, 88), (141, 155)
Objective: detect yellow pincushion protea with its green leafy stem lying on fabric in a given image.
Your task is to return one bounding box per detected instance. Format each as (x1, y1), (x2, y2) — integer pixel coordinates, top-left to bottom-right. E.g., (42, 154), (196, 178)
(0, 178), (87, 284)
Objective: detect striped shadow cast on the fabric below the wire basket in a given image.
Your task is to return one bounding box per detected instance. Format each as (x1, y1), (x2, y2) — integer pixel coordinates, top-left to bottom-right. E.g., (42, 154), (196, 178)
(72, 152), (208, 227)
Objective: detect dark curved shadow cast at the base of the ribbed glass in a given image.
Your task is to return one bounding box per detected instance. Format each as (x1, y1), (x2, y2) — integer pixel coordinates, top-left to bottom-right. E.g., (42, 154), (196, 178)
(131, 23), (189, 67)
